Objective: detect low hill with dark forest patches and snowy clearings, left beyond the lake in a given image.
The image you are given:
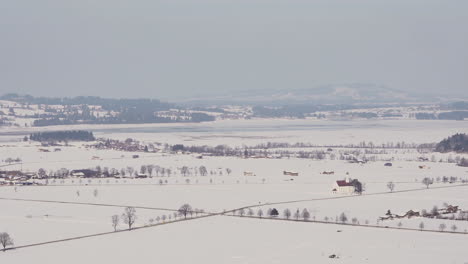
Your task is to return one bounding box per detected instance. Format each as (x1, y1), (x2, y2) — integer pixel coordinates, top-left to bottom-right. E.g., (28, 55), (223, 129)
(0, 94), (215, 127)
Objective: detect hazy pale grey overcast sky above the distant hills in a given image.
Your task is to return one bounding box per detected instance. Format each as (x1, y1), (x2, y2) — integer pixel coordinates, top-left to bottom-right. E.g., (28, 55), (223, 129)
(0, 0), (468, 98)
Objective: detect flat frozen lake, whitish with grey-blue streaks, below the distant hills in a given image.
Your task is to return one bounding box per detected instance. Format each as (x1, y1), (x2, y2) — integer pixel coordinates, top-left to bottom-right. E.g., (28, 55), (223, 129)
(0, 119), (468, 145)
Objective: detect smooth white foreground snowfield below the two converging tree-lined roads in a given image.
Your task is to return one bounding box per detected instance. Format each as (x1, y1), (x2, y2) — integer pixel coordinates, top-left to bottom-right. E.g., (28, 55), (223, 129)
(2, 216), (467, 264)
